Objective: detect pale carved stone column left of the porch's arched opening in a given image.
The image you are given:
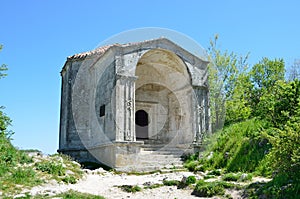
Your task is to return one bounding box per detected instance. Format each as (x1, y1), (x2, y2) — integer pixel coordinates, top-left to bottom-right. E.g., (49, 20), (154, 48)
(116, 74), (137, 141)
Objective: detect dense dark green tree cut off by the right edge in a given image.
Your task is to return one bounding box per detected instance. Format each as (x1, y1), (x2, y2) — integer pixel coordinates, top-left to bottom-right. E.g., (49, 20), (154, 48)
(260, 80), (300, 181)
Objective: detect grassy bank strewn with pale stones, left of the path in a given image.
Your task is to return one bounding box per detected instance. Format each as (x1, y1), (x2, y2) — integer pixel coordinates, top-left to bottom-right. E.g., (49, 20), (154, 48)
(0, 134), (83, 198)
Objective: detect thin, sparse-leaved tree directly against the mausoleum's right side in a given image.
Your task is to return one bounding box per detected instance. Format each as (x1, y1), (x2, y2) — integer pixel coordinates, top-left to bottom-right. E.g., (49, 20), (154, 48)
(208, 35), (249, 131)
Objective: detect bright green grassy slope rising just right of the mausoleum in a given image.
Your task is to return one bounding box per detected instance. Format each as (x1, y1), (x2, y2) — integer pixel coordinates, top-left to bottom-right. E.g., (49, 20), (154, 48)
(194, 119), (270, 175)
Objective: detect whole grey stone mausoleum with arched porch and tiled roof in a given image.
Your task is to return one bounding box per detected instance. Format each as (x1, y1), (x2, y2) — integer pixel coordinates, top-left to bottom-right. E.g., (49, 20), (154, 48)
(58, 38), (210, 171)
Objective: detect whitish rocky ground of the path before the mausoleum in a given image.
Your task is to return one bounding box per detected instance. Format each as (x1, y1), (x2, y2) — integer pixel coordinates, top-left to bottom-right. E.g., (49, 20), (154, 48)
(19, 168), (267, 199)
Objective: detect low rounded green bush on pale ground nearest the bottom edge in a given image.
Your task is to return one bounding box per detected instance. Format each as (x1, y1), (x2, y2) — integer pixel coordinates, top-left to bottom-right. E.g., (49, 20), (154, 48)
(192, 180), (225, 197)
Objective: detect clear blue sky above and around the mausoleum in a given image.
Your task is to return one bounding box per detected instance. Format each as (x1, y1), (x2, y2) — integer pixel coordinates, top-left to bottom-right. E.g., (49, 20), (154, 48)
(0, 0), (300, 153)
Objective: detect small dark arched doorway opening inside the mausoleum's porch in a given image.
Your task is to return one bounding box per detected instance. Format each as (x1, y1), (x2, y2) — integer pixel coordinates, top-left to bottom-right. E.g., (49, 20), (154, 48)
(135, 110), (149, 139)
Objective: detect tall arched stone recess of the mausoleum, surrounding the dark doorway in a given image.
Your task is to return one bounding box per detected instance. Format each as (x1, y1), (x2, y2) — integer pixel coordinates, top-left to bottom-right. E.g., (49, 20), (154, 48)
(135, 49), (193, 144)
